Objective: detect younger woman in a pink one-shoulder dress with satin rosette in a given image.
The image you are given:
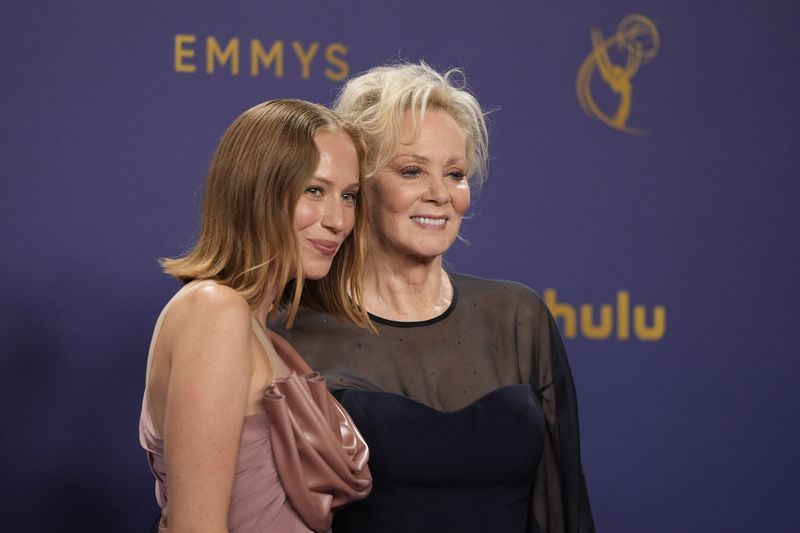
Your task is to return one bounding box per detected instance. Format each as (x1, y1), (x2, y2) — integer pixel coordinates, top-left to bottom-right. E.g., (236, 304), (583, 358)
(140, 100), (370, 533)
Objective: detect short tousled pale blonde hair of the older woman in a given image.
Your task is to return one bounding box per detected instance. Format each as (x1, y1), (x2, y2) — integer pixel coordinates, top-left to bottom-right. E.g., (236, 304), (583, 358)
(334, 62), (489, 188)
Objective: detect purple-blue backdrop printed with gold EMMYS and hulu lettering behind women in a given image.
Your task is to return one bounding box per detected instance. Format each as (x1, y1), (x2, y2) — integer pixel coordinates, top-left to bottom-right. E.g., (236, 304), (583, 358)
(0, 0), (800, 533)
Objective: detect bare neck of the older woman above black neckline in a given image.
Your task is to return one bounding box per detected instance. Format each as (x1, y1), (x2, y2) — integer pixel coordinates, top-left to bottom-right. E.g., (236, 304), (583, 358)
(364, 248), (453, 322)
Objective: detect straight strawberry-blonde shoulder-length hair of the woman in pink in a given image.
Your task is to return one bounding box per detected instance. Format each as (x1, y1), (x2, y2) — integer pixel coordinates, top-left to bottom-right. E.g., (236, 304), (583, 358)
(165, 100), (371, 327)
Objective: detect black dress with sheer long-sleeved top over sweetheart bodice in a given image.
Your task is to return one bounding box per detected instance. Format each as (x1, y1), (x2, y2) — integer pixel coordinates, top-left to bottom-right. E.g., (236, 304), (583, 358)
(273, 274), (594, 533)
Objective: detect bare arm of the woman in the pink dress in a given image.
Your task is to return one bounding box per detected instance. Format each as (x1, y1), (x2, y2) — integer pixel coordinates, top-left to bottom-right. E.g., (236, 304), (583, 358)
(164, 285), (253, 531)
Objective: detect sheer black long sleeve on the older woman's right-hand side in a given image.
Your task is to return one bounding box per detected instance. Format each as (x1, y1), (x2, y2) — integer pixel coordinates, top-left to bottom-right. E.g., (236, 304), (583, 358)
(528, 308), (595, 533)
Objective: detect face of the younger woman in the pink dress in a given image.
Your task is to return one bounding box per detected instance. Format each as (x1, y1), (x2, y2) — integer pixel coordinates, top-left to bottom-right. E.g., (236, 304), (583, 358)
(294, 132), (359, 279)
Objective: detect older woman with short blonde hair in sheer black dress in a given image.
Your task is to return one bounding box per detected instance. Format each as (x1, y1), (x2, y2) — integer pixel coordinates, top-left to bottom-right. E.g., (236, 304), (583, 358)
(276, 63), (594, 533)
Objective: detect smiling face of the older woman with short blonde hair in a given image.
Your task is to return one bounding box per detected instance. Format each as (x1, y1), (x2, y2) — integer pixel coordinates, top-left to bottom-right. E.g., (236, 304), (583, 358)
(367, 110), (470, 261)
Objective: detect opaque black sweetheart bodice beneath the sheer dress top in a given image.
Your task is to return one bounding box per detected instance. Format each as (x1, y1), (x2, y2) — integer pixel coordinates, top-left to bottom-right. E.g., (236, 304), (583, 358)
(334, 385), (545, 533)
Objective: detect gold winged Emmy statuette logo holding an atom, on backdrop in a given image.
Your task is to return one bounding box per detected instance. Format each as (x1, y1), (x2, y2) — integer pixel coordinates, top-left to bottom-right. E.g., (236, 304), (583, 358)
(576, 14), (660, 135)
